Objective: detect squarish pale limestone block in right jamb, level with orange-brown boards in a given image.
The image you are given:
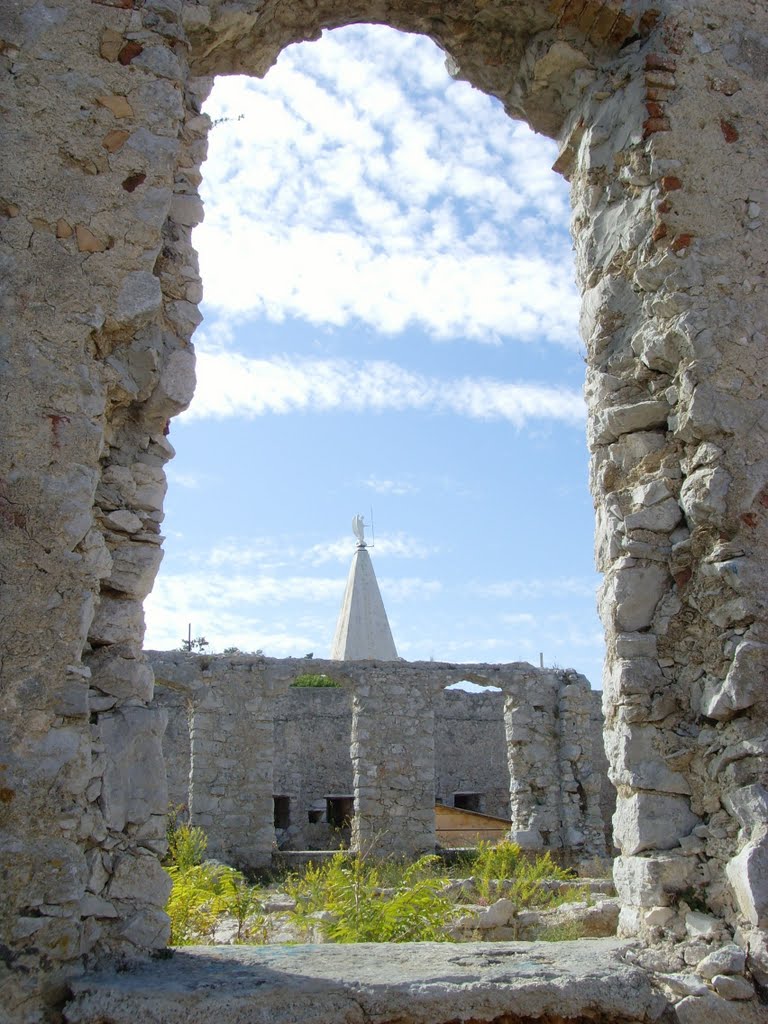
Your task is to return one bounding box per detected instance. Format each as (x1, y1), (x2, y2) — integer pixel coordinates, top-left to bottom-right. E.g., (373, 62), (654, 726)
(613, 792), (699, 856)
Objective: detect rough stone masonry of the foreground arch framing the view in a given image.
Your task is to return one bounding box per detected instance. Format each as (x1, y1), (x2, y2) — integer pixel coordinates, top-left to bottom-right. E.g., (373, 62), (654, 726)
(0, 0), (768, 1019)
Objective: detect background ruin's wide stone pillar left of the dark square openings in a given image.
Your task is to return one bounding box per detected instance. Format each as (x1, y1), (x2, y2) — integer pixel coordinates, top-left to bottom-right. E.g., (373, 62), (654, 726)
(189, 666), (274, 869)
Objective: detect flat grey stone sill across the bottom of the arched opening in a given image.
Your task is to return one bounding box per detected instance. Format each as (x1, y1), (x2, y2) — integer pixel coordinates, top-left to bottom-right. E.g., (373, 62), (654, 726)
(65, 938), (668, 1024)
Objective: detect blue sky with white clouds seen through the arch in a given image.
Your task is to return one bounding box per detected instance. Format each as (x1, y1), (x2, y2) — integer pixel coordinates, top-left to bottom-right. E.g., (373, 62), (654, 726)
(145, 27), (602, 685)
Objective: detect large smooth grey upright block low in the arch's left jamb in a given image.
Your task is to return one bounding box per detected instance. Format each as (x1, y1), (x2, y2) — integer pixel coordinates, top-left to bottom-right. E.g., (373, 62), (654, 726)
(97, 708), (168, 829)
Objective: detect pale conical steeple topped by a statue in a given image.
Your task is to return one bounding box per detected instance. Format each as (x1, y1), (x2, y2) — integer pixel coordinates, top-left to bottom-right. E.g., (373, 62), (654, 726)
(331, 515), (397, 662)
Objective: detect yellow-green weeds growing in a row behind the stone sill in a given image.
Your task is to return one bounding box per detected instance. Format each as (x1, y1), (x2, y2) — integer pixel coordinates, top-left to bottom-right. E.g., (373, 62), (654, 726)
(166, 808), (589, 945)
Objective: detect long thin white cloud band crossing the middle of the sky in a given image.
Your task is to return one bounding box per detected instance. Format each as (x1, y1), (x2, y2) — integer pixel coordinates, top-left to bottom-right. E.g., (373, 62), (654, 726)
(182, 351), (585, 427)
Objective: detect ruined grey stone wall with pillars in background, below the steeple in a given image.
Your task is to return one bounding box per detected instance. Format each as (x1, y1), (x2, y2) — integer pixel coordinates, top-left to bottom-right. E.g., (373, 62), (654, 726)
(148, 651), (605, 867)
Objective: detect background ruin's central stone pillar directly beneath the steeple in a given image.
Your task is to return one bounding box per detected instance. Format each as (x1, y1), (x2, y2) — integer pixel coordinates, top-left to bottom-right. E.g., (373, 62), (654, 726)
(346, 663), (436, 856)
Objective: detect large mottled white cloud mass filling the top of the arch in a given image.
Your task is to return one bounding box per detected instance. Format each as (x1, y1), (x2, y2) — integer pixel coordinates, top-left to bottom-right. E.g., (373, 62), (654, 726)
(195, 27), (578, 347)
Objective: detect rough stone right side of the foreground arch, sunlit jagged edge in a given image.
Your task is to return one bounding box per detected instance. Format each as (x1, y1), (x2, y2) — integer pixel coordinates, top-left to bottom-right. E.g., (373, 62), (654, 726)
(557, 0), (768, 950)
